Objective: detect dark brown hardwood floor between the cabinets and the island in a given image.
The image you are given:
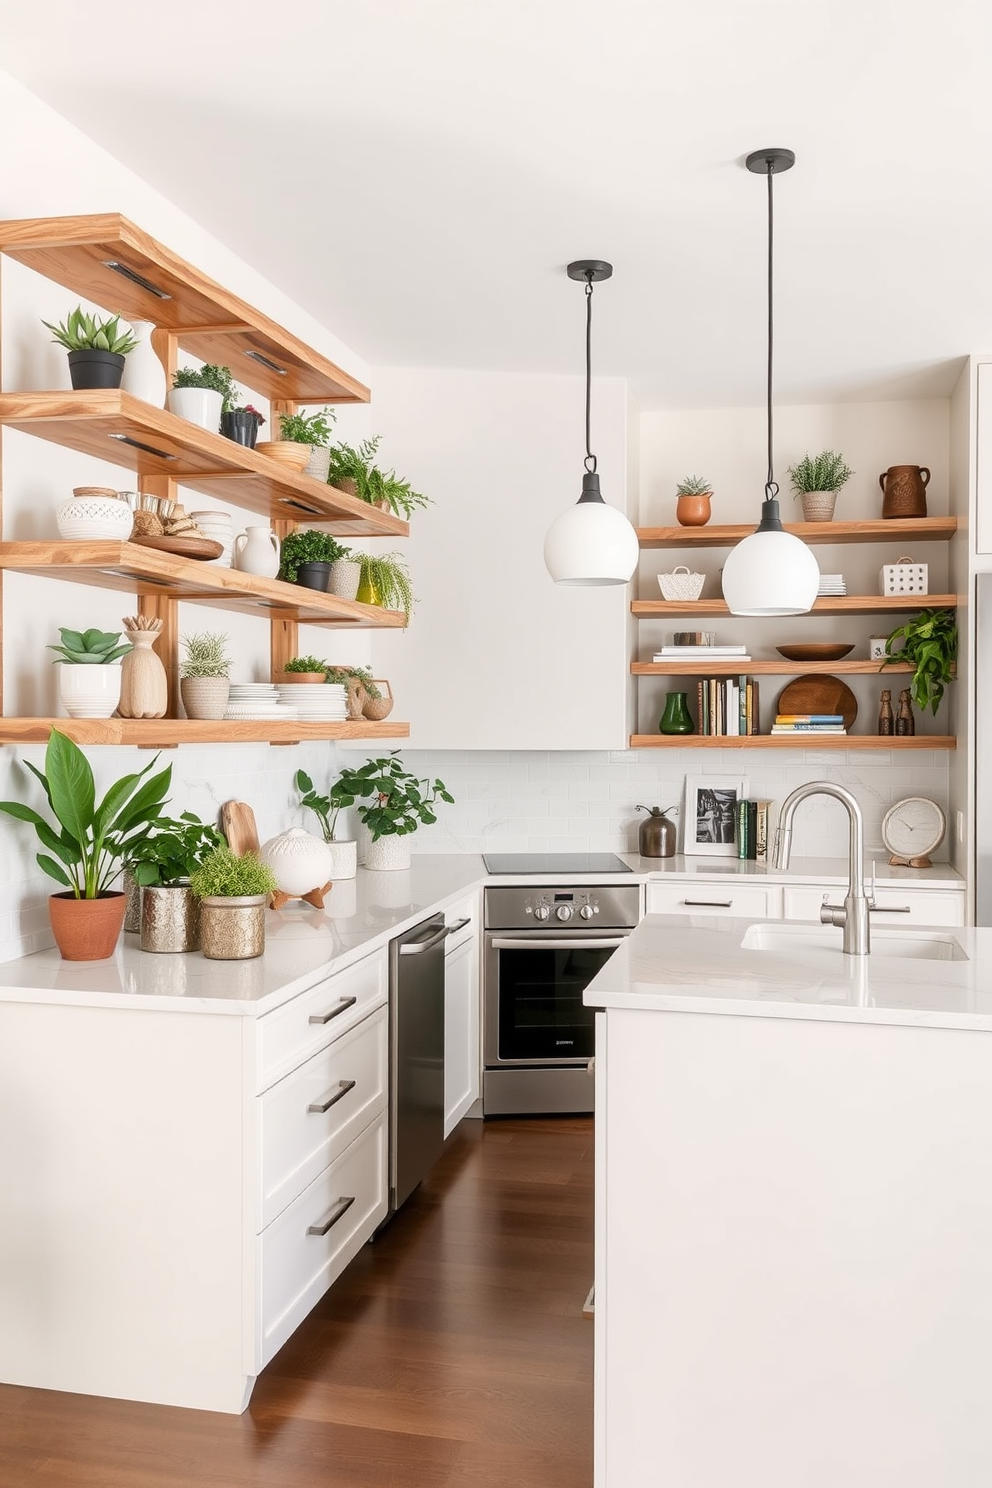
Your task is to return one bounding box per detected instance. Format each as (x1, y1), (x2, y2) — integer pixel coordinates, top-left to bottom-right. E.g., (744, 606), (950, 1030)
(0, 1117), (593, 1488)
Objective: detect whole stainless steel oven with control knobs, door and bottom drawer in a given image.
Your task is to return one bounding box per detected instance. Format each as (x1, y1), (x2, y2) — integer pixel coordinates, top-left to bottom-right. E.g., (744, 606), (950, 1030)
(482, 884), (641, 1116)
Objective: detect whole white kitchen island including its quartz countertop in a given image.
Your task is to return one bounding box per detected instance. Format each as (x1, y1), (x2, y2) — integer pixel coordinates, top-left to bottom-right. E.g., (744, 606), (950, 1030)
(586, 915), (992, 1488)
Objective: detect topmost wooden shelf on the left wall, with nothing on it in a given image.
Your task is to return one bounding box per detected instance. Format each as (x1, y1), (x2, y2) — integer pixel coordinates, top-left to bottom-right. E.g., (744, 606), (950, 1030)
(0, 211), (370, 403)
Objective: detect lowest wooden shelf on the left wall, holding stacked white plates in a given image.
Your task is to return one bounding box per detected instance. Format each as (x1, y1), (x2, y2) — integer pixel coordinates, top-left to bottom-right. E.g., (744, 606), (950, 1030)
(0, 719), (410, 748)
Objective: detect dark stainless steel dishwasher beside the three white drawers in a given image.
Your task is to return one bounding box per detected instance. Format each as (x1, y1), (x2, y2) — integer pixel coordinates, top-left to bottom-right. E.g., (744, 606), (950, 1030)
(390, 915), (448, 1213)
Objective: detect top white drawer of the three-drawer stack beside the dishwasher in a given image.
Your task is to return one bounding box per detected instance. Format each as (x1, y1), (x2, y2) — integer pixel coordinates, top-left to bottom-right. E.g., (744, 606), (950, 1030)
(257, 946), (390, 1091)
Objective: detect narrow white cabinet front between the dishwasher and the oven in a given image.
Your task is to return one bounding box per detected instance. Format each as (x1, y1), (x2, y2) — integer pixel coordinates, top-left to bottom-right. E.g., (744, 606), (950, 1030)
(445, 893), (482, 1137)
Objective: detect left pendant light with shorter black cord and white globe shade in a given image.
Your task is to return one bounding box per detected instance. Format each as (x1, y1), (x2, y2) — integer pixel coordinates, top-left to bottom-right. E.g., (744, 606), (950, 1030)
(544, 259), (640, 585)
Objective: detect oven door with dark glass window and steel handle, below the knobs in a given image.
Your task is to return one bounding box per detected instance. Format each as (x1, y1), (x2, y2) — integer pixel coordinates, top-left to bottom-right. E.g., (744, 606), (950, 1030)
(483, 929), (629, 1068)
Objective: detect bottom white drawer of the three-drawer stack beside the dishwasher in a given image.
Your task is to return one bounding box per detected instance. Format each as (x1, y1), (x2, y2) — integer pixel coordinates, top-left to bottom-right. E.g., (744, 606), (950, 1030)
(256, 1112), (387, 1369)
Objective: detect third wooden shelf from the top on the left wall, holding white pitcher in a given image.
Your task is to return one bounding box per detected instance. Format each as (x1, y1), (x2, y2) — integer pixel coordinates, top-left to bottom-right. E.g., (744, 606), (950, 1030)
(0, 540), (406, 629)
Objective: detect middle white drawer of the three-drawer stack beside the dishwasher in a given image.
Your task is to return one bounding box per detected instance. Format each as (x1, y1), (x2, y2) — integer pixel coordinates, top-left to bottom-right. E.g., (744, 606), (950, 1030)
(256, 1007), (388, 1231)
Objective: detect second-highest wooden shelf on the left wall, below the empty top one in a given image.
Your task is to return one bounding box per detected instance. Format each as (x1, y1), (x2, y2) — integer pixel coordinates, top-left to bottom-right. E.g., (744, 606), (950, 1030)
(0, 388), (409, 537)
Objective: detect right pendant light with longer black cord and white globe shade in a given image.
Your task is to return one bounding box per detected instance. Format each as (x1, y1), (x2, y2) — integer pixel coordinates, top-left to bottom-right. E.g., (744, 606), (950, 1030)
(723, 150), (819, 615)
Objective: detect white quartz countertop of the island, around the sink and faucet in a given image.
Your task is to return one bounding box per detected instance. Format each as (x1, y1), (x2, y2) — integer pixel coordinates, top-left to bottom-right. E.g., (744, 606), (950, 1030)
(584, 915), (992, 1033)
